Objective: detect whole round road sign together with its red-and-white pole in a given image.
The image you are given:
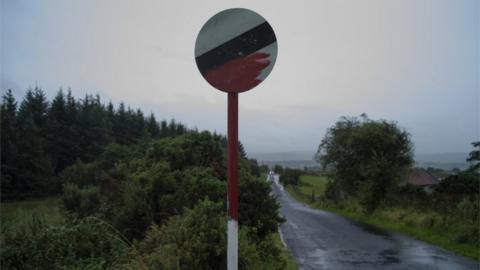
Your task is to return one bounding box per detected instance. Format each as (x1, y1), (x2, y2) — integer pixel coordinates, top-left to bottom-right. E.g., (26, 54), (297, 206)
(195, 8), (277, 270)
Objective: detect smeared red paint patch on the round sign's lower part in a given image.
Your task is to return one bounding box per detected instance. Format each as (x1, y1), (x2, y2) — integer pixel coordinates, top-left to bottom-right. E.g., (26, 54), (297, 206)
(205, 52), (270, 92)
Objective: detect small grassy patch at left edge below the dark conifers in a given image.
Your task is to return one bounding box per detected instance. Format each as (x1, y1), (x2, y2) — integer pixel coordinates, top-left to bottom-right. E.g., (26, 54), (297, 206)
(0, 197), (64, 232)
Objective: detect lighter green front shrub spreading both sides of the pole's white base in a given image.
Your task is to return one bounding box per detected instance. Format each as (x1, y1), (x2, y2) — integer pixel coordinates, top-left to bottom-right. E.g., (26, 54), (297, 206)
(119, 199), (285, 270)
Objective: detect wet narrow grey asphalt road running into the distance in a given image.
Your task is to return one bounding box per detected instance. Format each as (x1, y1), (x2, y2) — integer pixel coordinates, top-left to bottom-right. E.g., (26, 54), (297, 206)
(268, 175), (480, 270)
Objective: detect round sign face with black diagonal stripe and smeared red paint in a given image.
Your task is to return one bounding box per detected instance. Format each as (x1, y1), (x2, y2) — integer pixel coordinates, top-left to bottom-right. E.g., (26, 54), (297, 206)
(195, 8), (277, 93)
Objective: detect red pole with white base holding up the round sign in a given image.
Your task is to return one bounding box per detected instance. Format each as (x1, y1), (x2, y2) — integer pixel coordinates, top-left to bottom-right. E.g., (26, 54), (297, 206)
(227, 93), (238, 270)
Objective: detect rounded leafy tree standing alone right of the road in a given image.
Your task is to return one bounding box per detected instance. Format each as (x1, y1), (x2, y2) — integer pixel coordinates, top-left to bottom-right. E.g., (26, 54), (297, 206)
(316, 115), (413, 212)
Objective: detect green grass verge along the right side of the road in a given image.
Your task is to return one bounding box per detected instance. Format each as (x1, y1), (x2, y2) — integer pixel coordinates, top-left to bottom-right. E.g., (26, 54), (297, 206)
(286, 176), (480, 261)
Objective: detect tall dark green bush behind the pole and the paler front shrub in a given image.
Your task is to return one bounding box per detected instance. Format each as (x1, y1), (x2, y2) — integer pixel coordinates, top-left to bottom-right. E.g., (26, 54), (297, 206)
(63, 132), (282, 243)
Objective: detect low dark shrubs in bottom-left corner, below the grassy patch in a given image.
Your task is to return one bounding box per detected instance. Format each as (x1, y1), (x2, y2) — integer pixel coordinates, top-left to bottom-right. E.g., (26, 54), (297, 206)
(0, 219), (126, 270)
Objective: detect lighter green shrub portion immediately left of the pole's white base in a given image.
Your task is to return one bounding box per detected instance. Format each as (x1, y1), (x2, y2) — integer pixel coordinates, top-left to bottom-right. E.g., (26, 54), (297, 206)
(118, 200), (226, 269)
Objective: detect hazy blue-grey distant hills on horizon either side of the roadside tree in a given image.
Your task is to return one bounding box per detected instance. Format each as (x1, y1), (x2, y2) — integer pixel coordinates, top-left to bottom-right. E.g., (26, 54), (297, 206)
(248, 151), (468, 170)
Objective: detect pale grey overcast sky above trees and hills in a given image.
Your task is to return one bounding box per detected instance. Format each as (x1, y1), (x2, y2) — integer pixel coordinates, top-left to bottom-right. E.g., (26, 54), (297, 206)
(0, 0), (480, 153)
